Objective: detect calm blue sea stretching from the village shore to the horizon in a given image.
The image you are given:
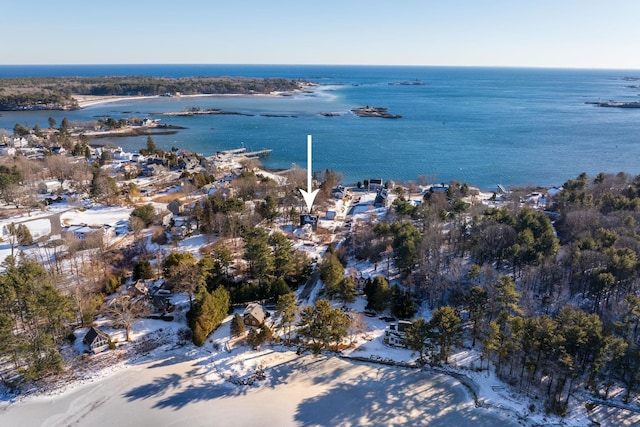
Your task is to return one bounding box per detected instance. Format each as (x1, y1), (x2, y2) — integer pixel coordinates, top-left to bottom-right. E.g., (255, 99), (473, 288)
(0, 65), (640, 189)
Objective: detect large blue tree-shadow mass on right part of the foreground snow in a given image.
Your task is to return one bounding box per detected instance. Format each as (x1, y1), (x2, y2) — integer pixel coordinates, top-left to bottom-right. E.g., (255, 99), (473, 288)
(295, 367), (510, 427)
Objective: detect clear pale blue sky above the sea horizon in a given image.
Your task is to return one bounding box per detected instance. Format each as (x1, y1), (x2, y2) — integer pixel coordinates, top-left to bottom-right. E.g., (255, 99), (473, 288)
(0, 0), (640, 69)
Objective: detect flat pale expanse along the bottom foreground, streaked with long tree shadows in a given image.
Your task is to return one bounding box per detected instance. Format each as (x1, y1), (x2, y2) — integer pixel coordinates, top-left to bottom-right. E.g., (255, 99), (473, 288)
(0, 351), (517, 427)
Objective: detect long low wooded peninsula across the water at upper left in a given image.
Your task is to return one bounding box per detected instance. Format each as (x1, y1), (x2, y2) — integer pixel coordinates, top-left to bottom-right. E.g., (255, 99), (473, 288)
(0, 76), (309, 111)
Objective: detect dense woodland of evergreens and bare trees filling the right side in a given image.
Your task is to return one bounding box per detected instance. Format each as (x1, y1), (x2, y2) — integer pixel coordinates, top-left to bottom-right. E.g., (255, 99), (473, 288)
(349, 174), (640, 414)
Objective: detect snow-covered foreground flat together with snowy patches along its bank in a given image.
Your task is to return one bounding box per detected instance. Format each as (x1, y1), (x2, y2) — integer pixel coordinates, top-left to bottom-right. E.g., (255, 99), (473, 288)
(0, 308), (517, 426)
